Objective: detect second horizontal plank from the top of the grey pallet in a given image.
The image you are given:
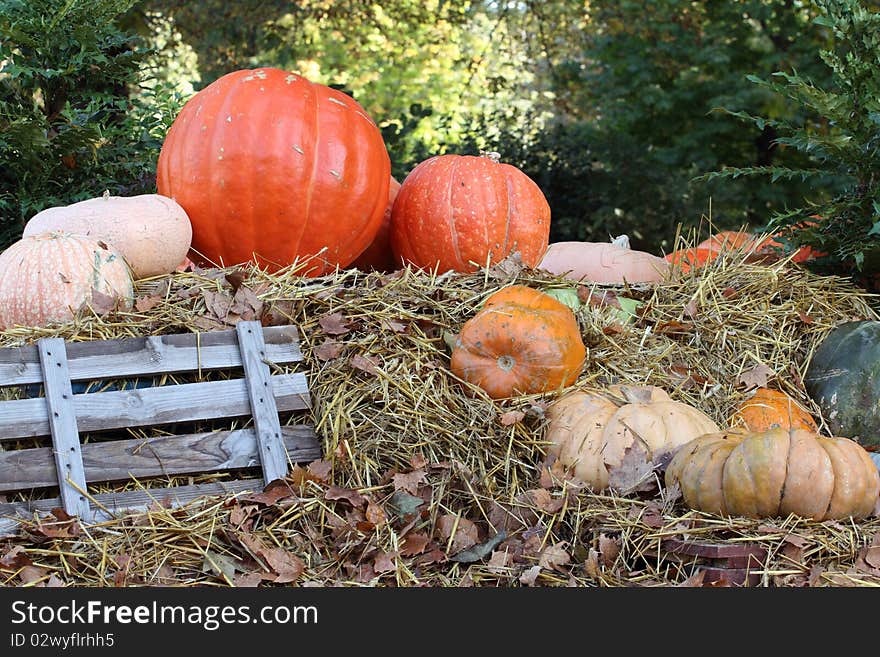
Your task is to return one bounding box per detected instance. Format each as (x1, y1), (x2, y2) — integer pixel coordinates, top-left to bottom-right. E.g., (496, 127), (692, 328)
(0, 373), (310, 441)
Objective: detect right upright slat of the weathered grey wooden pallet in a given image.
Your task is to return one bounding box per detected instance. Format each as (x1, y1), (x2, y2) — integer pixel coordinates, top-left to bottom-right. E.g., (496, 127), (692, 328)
(235, 322), (288, 486)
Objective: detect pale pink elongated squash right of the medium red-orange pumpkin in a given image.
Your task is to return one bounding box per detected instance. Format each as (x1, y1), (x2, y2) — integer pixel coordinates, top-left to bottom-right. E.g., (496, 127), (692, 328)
(538, 242), (670, 285)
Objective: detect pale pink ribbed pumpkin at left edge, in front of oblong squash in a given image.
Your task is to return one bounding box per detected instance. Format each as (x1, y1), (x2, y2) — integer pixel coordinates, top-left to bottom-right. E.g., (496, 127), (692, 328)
(0, 232), (134, 330)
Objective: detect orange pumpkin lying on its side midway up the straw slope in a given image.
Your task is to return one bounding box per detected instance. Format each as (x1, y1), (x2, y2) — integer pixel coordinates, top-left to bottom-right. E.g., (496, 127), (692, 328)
(450, 285), (586, 399)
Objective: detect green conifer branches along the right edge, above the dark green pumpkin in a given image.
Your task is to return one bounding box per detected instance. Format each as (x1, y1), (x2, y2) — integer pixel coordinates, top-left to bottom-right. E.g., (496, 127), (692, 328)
(707, 0), (880, 282)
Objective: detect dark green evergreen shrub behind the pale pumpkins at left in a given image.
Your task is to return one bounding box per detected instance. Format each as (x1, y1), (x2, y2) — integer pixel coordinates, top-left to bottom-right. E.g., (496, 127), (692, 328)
(0, 0), (179, 246)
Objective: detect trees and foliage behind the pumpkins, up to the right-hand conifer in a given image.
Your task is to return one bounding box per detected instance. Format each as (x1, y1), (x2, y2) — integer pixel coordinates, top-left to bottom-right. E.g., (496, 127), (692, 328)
(0, 0), (880, 270)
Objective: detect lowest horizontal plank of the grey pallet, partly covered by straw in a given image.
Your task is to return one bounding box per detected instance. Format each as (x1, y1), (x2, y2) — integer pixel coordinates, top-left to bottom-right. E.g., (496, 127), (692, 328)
(0, 479), (263, 537)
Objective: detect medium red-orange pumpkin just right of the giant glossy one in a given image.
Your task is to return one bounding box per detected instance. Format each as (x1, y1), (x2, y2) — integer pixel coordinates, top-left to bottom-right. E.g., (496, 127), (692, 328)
(391, 155), (550, 272)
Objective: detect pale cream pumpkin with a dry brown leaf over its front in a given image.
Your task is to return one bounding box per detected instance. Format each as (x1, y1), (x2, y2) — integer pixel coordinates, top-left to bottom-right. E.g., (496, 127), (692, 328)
(546, 386), (719, 491)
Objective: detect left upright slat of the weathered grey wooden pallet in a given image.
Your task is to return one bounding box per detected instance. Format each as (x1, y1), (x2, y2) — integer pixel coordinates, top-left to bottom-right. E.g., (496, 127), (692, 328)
(37, 338), (89, 519)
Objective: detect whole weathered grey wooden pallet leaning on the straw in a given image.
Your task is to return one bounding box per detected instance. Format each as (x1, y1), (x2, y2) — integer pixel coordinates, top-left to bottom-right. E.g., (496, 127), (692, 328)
(0, 322), (321, 535)
